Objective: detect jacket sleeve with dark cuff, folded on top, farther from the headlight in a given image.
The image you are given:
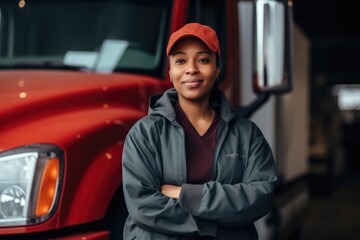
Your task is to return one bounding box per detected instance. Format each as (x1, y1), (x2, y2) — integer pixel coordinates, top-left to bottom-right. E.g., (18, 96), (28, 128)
(179, 124), (277, 226)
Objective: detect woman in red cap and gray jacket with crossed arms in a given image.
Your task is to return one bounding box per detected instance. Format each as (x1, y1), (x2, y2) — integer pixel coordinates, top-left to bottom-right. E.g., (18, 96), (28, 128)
(123, 23), (277, 240)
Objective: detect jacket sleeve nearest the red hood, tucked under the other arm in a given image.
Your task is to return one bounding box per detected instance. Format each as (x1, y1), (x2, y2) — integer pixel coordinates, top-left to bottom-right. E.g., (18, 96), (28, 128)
(122, 125), (217, 236)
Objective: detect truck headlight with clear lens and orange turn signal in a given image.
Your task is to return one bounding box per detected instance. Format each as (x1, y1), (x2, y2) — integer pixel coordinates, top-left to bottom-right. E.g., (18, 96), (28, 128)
(0, 144), (64, 227)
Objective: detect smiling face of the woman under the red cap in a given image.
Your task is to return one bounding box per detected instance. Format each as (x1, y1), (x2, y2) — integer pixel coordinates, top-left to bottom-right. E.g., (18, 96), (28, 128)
(169, 38), (219, 102)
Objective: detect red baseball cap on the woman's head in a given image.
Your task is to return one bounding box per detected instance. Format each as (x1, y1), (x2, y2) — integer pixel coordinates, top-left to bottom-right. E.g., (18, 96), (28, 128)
(166, 23), (220, 58)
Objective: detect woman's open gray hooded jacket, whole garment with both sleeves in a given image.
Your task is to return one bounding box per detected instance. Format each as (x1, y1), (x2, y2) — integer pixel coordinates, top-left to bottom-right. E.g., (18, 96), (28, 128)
(122, 89), (277, 240)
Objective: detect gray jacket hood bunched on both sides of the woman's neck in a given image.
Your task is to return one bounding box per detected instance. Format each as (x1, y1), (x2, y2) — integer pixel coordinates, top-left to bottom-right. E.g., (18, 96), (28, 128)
(148, 85), (236, 122)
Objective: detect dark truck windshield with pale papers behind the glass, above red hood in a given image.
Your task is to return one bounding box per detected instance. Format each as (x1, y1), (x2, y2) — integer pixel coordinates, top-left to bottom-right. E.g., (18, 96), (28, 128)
(0, 0), (169, 72)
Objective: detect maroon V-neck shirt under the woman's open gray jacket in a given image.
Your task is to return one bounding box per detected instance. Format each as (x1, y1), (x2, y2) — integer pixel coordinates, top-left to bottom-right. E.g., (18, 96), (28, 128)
(175, 103), (220, 240)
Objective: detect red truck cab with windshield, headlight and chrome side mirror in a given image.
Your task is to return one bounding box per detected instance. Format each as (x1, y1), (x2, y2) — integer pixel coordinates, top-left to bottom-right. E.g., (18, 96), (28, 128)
(0, 0), (310, 240)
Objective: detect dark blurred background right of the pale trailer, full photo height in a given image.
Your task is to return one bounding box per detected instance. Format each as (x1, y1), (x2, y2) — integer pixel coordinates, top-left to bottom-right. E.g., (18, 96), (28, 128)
(293, 0), (360, 240)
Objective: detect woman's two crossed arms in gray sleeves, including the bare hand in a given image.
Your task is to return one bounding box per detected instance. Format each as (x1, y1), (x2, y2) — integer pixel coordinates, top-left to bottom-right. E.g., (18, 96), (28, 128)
(123, 124), (276, 236)
